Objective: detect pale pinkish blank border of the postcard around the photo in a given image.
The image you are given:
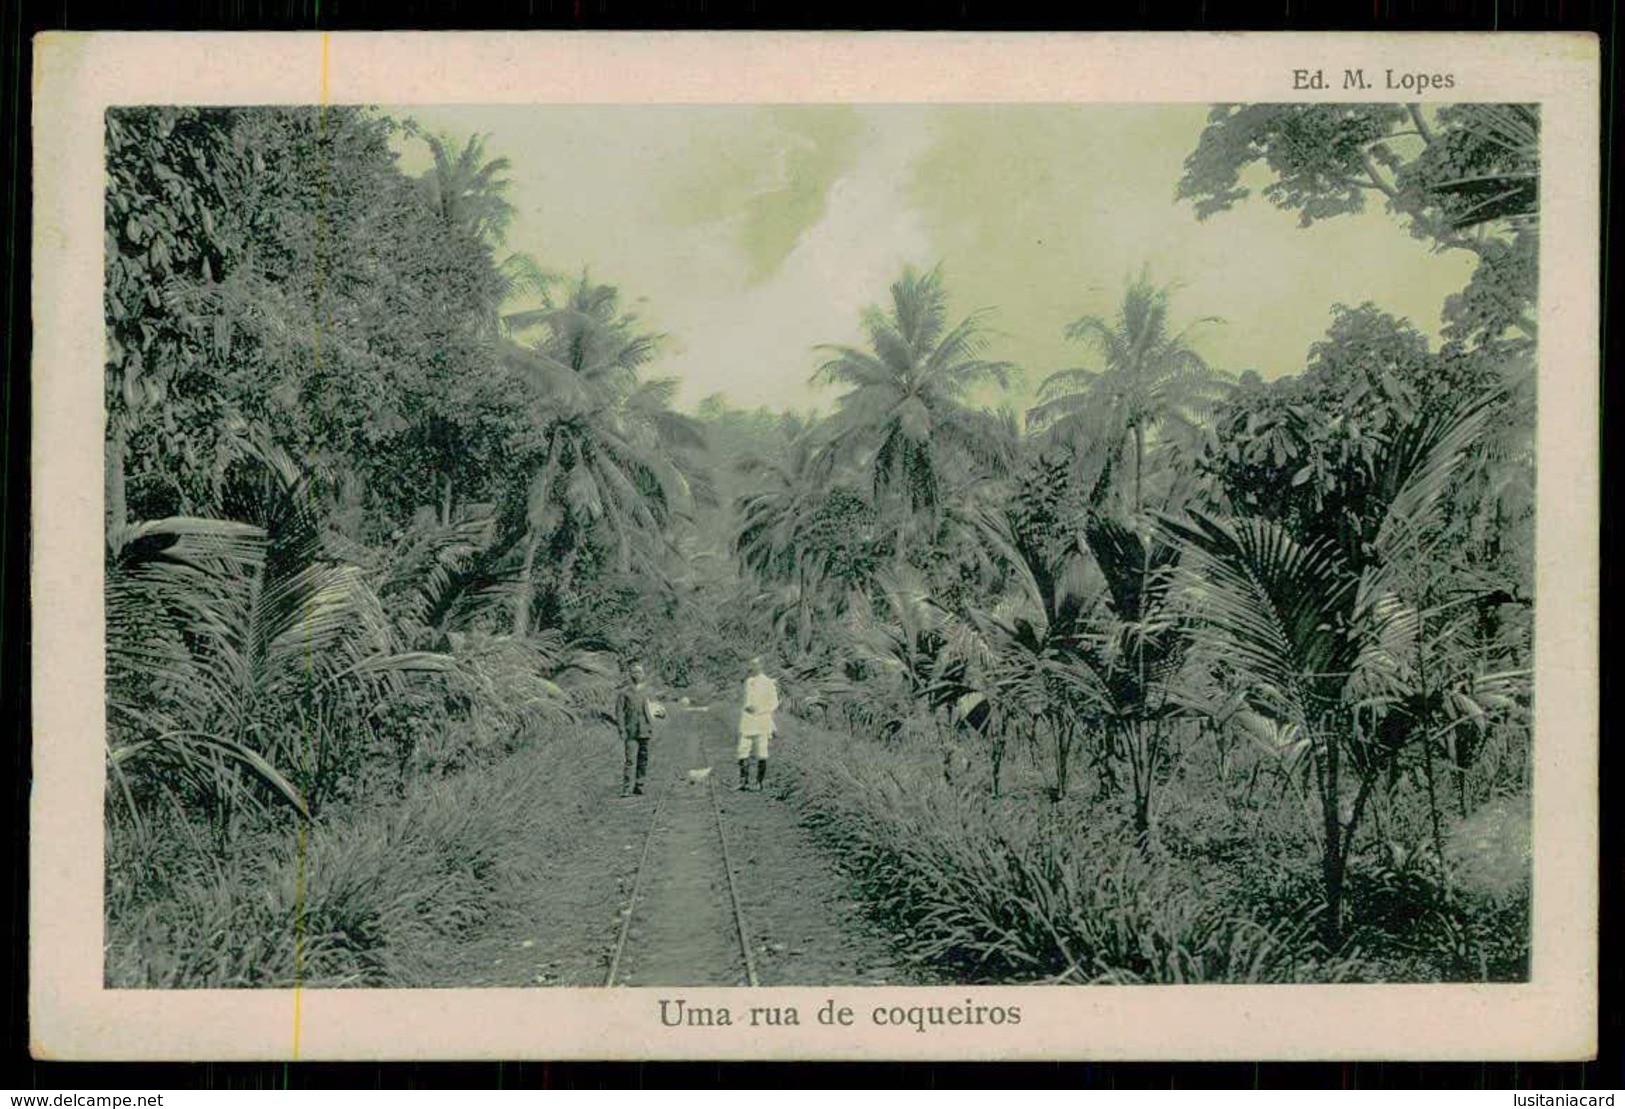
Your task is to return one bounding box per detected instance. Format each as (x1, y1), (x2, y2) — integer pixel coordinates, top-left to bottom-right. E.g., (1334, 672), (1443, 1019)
(29, 33), (1601, 1060)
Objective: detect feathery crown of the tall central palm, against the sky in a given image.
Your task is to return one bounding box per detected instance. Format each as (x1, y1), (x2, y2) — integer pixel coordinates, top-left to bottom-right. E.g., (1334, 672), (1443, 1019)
(814, 267), (1012, 549)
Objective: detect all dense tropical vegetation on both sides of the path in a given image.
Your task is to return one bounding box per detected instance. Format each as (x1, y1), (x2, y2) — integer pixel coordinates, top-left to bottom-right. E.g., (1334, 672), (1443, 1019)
(106, 106), (1537, 985)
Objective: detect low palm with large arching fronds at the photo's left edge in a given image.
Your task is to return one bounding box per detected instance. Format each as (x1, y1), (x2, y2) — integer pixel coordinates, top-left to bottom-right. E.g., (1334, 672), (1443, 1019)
(106, 444), (450, 837)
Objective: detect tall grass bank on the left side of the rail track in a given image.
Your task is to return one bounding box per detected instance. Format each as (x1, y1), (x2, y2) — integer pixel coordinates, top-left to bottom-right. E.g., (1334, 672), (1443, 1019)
(106, 728), (605, 989)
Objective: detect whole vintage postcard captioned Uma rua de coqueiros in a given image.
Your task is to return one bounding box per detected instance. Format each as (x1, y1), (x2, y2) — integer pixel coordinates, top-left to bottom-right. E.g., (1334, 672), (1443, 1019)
(29, 33), (1599, 1060)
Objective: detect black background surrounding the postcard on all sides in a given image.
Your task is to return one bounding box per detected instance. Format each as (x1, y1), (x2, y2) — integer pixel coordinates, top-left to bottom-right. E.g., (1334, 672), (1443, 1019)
(0, 0), (1625, 1093)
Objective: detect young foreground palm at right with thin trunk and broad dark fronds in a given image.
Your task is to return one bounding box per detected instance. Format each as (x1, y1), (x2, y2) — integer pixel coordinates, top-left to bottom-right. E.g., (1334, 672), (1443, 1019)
(1160, 388), (1493, 946)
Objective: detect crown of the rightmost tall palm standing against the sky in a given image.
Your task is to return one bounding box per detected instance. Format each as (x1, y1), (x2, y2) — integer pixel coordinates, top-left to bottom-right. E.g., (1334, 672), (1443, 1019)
(1027, 270), (1229, 517)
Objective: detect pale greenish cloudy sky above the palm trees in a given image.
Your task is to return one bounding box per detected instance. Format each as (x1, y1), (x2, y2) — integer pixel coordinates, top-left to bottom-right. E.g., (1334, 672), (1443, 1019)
(388, 104), (1472, 410)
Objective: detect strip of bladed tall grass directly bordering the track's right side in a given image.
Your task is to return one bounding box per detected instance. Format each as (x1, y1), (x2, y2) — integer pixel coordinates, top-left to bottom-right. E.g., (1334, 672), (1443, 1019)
(780, 737), (1360, 982)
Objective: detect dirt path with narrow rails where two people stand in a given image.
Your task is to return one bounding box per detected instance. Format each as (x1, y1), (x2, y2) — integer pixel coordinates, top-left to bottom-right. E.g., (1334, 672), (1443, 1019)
(447, 709), (908, 987)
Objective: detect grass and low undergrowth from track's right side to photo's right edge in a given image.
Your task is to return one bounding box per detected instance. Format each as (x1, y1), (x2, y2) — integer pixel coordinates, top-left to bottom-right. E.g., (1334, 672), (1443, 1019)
(791, 715), (1528, 984)
